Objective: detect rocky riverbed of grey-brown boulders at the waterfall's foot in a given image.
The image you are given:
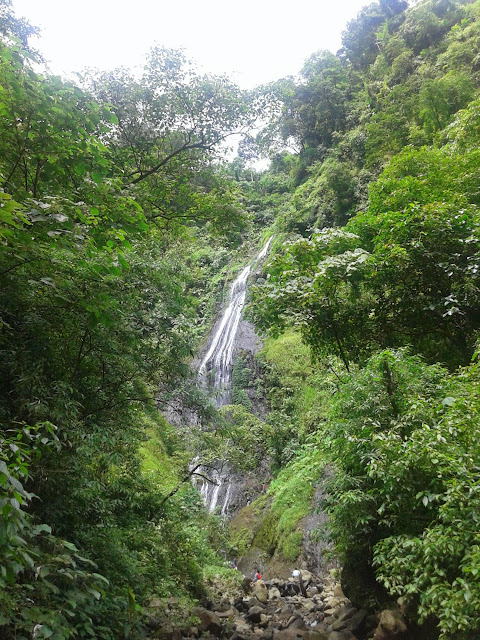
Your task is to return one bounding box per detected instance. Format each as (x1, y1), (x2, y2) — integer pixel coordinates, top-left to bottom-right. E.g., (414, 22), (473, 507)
(149, 571), (408, 640)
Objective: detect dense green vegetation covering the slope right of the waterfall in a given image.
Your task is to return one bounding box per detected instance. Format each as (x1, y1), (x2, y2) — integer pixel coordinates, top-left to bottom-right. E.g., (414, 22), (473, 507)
(246, 0), (480, 639)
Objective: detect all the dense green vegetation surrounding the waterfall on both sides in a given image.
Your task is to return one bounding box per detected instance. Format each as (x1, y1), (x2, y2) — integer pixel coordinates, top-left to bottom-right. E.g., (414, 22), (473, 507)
(0, 0), (480, 640)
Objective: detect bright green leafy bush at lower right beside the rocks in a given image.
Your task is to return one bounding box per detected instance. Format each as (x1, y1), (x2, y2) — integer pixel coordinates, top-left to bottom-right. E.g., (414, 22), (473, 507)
(316, 351), (479, 638)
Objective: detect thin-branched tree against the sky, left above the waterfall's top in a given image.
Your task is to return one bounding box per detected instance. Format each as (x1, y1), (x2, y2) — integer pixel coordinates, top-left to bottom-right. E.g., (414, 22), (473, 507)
(84, 48), (262, 234)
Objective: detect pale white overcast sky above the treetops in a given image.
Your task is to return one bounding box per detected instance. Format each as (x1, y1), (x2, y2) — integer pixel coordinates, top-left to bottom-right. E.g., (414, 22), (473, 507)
(13, 0), (368, 88)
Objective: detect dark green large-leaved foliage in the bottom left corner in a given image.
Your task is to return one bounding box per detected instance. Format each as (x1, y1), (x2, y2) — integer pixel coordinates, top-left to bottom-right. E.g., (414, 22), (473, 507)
(0, 423), (113, 639)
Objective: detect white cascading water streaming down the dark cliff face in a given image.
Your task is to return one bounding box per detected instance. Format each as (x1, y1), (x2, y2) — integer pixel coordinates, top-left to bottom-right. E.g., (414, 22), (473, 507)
(196, 237), (272, 515)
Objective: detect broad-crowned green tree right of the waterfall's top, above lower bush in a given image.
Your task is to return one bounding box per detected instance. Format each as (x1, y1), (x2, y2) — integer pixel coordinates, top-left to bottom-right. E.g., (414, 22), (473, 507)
(252, 145), (479, 367)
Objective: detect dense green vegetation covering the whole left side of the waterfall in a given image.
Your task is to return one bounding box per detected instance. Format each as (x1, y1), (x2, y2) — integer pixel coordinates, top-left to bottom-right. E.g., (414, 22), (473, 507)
(0, 2), (256, 638)
